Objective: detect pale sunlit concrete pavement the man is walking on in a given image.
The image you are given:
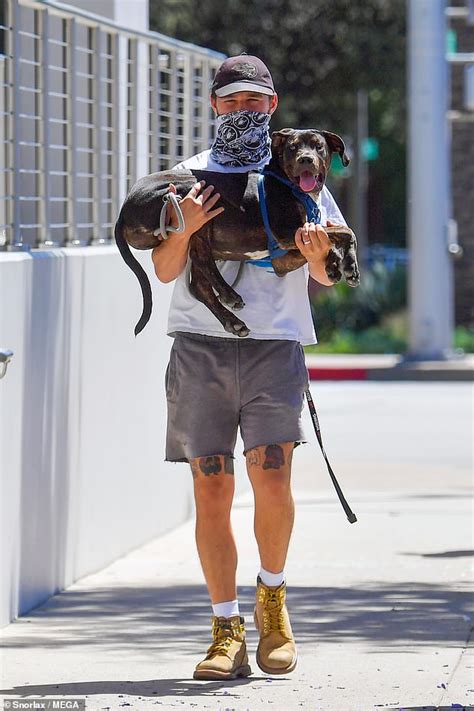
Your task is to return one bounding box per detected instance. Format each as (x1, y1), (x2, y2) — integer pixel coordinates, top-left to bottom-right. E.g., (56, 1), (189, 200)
(1, 383), (474, 711)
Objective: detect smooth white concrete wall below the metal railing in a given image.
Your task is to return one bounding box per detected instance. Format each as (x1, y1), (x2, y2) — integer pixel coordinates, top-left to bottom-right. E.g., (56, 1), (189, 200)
(0, 247), (192, 625)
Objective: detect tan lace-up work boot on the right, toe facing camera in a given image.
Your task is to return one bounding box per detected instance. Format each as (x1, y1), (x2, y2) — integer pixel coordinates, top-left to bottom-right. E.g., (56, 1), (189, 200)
(254, 576), (297, 674)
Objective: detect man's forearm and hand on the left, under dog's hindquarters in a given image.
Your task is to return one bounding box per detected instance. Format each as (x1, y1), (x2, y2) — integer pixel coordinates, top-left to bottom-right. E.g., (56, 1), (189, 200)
(151, 180), (224, 283)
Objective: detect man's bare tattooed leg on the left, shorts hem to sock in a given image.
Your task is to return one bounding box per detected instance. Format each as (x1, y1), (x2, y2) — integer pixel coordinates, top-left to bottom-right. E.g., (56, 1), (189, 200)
(190, 455), (237, 605)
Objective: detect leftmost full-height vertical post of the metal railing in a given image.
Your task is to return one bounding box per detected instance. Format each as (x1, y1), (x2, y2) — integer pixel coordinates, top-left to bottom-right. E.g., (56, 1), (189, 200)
(11, 0), (23, 249)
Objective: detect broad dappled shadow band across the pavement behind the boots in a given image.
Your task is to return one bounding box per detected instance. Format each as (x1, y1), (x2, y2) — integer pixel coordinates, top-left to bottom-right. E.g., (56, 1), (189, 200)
(0, 582), (472, 658)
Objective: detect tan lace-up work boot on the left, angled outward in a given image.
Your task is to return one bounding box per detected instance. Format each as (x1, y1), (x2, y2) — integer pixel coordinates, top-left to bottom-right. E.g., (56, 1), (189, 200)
(193, 615), (252, 679)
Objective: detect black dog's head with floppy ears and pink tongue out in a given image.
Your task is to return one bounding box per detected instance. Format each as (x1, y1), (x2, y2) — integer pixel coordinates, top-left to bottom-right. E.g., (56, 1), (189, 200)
(272, 128), (349, 193)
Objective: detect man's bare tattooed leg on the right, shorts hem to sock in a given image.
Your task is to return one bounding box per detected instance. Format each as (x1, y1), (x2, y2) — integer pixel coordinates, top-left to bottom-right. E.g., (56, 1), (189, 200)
(246, 442), (295, 573)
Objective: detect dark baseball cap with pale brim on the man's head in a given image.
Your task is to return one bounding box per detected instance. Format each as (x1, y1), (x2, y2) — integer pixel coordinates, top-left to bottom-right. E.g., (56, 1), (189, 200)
(211, 54), (275, 97)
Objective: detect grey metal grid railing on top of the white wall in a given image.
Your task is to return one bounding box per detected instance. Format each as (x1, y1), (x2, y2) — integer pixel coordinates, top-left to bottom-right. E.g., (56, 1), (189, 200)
(0, 0), (223, 249)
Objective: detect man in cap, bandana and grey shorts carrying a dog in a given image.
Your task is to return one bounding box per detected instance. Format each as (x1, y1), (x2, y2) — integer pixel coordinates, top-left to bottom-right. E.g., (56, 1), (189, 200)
(152, 55), (344, 679)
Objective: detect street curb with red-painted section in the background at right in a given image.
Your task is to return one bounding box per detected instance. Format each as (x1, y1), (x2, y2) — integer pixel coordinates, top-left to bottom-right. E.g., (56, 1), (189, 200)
(306, 353), (474, 382)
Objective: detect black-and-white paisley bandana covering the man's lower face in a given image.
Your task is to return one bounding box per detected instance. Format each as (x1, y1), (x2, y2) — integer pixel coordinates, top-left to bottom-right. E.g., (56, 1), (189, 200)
(211, 110), (271, 168)
